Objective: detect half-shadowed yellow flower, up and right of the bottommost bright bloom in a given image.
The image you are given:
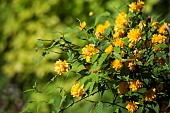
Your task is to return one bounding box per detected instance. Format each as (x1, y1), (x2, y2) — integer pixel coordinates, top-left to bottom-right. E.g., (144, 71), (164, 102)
(143, 88), (156, 102)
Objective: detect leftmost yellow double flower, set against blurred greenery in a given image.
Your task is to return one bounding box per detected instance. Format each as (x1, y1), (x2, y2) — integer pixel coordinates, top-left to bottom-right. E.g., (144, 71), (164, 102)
(55, 60), (69, 75)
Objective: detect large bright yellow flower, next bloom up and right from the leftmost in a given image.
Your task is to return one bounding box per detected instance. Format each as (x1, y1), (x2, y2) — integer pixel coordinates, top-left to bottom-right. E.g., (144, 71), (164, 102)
(82, 44), (99, 62)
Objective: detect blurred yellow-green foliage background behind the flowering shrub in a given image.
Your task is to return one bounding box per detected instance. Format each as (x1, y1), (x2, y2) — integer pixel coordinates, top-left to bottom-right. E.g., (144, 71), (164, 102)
(0, 0), (170, 113)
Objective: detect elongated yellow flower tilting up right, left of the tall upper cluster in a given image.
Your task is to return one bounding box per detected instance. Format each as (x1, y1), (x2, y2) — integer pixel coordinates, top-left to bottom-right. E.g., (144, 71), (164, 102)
(95, 21), (110, 38)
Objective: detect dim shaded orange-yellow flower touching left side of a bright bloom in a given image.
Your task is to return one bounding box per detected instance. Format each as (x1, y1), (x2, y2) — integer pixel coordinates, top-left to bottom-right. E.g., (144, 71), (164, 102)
(117, 82), (128, 94)
